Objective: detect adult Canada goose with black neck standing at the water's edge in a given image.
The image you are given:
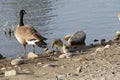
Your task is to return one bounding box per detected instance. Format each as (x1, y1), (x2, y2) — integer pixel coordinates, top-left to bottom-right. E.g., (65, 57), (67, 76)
(14, 10), (47, 53)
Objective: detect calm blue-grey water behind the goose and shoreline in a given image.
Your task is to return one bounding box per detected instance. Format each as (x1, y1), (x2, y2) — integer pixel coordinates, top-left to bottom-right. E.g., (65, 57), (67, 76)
(0, 0), (120, 57)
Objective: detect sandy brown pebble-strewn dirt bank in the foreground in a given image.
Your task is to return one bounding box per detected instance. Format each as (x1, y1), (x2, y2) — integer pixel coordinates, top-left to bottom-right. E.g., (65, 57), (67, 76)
(0, 44), (120, 80)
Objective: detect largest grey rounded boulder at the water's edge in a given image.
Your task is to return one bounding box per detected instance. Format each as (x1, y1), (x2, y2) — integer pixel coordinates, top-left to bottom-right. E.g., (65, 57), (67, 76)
(68, 31), (86, 46)
